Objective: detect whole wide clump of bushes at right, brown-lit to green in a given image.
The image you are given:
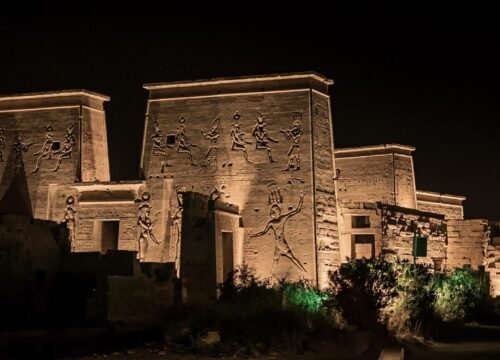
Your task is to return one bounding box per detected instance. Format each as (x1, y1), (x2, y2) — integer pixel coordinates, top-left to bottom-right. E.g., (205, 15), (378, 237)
(330, 259), (487, 337)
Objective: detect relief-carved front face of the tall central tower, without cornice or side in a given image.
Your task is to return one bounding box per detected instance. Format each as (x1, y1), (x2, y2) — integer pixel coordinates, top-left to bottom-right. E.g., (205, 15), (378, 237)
(142, 90), (320, 281)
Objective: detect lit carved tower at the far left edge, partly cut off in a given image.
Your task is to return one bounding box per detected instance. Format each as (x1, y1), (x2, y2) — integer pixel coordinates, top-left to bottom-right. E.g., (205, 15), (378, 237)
(0, 90), (109, 219)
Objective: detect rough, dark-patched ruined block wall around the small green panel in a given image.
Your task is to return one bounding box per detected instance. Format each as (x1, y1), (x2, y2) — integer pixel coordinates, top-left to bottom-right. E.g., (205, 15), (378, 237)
(381, 206), (447, 269)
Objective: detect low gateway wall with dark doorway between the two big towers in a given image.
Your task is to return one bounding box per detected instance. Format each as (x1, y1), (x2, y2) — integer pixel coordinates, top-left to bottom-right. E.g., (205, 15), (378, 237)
(49, 178), (173, 262)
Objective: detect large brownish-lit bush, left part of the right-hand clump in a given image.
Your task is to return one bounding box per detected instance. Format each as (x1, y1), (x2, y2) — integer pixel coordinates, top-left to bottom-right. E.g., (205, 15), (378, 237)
(330, 259), (432, 337)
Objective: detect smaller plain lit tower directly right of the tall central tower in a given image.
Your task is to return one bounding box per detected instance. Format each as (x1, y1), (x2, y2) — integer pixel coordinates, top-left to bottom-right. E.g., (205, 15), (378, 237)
(335, 144), (416, 262)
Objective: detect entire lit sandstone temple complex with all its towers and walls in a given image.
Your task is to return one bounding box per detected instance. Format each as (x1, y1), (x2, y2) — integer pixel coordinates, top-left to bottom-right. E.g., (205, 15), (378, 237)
(0, 72), (500, 295)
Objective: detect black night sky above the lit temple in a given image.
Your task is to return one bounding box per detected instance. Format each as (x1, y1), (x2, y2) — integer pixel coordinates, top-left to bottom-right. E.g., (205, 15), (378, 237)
(0, 2), (500, 220)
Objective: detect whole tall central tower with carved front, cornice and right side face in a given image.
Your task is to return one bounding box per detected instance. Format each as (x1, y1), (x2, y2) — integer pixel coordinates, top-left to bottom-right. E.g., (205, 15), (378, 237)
(141, 73), (338, 283)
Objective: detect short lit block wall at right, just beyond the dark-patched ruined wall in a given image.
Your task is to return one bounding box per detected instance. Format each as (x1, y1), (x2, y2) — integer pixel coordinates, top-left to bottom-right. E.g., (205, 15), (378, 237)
(447, 219), (490, 270)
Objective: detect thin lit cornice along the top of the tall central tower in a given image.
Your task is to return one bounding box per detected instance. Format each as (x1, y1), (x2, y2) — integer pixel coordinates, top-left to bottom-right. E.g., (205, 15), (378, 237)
(143, 71), (334, 90)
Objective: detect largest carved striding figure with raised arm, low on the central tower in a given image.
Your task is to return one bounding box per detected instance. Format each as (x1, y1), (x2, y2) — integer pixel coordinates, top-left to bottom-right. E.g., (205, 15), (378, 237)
(249, 192), (307, 276)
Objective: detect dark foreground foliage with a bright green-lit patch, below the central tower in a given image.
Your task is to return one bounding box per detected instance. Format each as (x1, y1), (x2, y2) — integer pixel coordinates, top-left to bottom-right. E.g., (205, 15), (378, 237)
(164, 266), (345, 355)
